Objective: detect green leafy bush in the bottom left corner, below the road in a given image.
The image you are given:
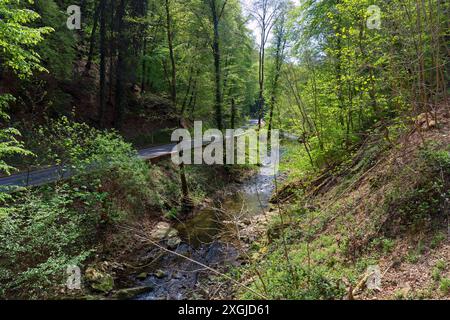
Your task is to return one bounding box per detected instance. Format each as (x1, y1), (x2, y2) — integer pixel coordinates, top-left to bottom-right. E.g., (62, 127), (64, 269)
(0, 185), (100, 297)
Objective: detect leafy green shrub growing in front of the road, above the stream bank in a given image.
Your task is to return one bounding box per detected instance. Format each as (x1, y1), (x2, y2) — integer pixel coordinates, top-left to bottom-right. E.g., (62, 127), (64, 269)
(30, 117), (177, 210)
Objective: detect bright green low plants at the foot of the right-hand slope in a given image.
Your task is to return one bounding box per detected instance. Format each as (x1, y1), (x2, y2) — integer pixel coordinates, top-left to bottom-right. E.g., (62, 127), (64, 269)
(241, 209), (356, 300)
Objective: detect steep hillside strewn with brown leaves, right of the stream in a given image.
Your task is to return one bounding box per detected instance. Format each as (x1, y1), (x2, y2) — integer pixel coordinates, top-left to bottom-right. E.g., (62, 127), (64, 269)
(237, 110), (450, 299)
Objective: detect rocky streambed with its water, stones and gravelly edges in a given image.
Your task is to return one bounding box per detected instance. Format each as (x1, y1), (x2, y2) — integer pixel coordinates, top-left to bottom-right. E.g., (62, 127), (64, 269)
(129, 167), (282, 300)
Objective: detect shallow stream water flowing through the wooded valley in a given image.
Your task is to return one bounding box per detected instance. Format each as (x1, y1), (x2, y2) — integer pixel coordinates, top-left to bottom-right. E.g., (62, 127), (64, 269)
(136, 162), (275, 300)
